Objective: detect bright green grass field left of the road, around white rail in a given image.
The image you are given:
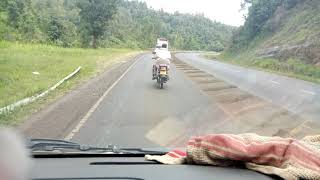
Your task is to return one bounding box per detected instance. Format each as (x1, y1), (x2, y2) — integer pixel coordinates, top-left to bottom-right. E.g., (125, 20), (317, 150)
(0, 41), (139, 125)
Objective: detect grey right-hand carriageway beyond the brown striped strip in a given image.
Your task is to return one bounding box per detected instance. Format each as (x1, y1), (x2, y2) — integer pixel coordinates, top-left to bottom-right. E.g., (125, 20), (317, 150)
(177, 53), (320, 120)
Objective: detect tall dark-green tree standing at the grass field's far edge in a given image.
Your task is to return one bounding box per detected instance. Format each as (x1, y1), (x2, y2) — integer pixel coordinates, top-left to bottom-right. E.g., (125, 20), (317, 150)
(78, 0), (117, 48)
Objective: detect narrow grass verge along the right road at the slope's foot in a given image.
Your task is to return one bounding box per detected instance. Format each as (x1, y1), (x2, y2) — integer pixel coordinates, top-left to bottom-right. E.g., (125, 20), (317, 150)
(202, 53), (320, 83)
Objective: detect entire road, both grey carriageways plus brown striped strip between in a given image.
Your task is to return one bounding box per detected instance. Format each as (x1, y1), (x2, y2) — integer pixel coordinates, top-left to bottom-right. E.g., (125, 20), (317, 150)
(68, 53), (320, 148)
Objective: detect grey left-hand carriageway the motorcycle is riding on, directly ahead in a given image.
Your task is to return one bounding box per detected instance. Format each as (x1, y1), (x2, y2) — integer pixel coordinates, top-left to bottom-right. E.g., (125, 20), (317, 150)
(71, 55), (225, 147)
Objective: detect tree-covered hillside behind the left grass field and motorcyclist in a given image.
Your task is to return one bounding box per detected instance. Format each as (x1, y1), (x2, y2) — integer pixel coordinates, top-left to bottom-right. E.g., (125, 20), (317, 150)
(0, 0), (235, 51)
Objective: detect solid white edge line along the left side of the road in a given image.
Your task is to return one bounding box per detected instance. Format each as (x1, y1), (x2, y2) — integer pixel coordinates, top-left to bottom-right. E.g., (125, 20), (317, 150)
(64, 57), (140, 141)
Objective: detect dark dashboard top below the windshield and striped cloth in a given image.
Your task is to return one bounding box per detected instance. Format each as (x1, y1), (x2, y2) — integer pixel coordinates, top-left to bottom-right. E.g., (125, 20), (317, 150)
(31, 157), (273, 180)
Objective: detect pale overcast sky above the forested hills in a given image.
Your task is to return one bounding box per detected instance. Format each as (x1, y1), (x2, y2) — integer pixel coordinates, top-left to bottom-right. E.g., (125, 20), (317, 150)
(140, 0), (244, 26)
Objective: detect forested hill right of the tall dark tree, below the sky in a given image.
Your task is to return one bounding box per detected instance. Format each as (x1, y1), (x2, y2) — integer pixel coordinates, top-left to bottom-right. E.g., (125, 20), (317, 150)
(105, 1), (235, 51)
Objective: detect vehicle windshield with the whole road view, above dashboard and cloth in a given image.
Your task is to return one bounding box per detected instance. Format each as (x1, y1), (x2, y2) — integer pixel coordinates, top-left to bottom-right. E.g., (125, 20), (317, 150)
(0, 0), (320, 152)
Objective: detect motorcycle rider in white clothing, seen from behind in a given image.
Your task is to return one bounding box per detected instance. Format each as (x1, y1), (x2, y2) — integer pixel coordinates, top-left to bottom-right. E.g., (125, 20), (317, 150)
(152, 50), (171, 80)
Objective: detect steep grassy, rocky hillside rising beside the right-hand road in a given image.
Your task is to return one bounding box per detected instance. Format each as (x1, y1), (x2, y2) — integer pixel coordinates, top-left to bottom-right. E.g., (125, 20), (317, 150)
(221, 0), (320, 82)
